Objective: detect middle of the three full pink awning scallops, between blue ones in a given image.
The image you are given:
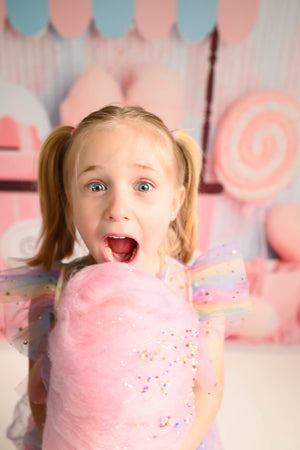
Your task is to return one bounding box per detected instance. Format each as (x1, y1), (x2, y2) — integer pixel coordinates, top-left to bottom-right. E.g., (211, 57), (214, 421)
(135, 0), (177, 41)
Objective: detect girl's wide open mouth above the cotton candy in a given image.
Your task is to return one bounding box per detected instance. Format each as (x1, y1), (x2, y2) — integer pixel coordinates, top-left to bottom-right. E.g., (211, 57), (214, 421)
(102, 235), (138, 263)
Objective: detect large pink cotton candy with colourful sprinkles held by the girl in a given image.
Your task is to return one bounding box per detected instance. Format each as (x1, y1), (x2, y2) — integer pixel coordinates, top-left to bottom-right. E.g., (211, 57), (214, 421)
(42, 263), (199, 450)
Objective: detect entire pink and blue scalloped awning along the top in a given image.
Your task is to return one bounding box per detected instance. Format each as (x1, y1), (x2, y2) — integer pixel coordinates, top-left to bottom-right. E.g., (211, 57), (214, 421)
(0, 0), (259, 42)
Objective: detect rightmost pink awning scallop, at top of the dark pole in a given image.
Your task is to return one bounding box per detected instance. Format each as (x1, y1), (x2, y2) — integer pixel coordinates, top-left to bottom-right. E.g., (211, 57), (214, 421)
(217, 0), (260, 42)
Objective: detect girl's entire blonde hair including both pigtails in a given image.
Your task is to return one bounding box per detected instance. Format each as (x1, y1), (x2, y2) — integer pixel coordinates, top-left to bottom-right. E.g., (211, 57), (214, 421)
(28, 105), (201, 268)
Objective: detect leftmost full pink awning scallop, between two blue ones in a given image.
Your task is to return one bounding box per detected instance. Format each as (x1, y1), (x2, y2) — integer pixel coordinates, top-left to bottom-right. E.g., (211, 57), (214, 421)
(49, 0), (92, 38)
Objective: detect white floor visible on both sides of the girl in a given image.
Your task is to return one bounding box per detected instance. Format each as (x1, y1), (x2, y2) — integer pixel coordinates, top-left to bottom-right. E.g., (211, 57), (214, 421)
(0, 341), (300, 450)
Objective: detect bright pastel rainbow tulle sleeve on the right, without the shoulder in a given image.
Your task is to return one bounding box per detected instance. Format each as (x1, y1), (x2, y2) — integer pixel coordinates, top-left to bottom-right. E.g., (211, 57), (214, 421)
(189, 243), (251, 336)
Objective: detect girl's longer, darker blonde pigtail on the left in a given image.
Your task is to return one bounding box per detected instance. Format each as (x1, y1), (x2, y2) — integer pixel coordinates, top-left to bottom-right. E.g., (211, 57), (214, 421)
(27, 126), (75, 269)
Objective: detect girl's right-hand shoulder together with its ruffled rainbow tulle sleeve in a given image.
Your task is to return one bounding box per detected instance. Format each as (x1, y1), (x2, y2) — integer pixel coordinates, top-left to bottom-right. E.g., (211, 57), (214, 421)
(160, 243), (251, 334)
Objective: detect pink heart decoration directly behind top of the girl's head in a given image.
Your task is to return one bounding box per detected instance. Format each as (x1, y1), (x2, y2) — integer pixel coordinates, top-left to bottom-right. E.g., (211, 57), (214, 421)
(60, 63), (184, 129)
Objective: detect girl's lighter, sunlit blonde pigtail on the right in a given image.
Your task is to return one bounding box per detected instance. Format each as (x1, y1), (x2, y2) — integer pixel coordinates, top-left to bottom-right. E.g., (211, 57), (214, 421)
(170, 130), (202, 263)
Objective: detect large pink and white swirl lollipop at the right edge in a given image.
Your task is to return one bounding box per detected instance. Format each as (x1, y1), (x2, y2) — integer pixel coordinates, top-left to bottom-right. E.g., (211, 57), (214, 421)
(214, 91), (300, 203)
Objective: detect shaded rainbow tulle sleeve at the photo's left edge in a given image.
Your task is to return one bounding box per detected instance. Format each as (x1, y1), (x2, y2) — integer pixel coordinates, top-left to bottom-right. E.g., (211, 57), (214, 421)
(0, 266), (60, 366)
